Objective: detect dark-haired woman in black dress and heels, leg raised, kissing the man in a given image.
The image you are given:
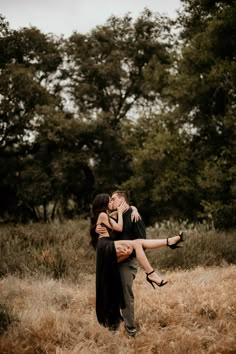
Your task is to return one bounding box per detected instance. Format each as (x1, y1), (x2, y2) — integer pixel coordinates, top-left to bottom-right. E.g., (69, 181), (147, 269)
(90, 194), (183, 329)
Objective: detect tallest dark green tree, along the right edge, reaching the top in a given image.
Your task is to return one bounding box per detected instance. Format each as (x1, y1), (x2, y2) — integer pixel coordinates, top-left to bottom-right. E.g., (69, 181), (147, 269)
(172, 0), (236, 227)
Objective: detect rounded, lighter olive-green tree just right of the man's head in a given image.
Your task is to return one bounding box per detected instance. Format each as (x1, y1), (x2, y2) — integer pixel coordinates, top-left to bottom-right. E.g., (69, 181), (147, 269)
(122, 112), (200, 224)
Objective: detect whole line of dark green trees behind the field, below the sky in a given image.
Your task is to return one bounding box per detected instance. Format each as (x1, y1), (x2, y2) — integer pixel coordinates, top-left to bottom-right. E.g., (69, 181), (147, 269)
(0, 0), (236, 228)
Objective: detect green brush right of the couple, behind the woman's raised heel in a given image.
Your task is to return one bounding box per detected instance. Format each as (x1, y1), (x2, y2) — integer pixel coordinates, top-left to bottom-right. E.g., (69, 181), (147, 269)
(147, 221), (236, 269)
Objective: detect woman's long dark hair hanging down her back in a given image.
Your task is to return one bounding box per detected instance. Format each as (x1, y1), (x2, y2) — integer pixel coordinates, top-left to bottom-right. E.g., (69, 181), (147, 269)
(90, 194), (110, 249)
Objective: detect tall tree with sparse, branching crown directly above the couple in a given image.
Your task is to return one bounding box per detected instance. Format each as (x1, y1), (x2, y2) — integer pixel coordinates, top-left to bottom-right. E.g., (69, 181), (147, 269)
(67, 9), (172, 191)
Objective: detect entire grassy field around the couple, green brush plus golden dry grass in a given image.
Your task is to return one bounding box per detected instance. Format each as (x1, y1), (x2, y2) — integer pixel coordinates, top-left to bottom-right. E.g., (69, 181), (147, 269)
(0, 220), (236, 354)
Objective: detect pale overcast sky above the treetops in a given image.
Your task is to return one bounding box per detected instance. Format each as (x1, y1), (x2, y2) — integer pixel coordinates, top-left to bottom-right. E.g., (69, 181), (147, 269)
(0, 0), (181, 37)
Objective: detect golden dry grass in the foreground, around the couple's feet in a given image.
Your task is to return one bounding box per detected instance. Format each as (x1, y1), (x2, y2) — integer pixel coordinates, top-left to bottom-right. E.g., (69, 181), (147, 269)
(0, 264), (236, 354)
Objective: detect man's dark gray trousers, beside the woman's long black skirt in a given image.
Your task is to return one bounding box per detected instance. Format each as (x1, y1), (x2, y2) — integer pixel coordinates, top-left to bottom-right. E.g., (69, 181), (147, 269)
(119, 257), (138, 332)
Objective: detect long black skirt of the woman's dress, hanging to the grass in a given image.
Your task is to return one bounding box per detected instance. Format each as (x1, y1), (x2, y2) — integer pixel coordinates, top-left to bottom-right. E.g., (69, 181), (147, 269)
(96, 237), (125, 330)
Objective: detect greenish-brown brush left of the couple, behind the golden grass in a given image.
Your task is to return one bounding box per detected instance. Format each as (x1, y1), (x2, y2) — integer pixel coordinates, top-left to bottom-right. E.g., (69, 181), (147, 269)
(0, 220), (95, 281)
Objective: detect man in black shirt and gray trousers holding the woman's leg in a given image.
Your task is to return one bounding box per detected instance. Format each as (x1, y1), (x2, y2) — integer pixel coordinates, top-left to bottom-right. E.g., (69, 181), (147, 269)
(111, 190), (146, 336)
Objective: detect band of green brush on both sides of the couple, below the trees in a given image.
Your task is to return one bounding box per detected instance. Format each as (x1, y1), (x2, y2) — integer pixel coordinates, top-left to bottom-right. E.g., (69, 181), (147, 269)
(0, 220), (236, 282)
